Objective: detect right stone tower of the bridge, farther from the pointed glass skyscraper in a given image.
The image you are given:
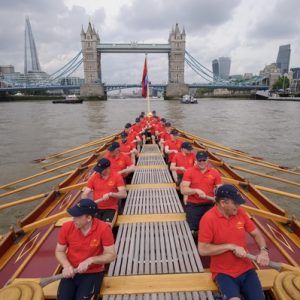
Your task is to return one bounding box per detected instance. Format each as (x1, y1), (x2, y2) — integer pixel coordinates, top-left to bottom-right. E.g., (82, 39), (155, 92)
(165, 23), (188, 99)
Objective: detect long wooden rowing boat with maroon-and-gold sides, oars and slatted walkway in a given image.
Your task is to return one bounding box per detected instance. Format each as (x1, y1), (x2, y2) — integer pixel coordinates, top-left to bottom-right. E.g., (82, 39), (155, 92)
(0, 113), (300, 300)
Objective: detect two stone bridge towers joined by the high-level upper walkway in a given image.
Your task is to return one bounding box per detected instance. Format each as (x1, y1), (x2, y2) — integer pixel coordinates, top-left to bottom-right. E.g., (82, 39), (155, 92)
(80, 23), (188, 99)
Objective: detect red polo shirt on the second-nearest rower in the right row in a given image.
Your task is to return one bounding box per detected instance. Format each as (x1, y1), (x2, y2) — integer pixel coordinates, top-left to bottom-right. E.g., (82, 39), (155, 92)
(182, 166), (222, 204)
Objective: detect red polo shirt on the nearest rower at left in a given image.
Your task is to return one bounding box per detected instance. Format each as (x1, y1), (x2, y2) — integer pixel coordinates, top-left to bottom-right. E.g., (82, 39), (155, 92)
(58, 218), (114, 273)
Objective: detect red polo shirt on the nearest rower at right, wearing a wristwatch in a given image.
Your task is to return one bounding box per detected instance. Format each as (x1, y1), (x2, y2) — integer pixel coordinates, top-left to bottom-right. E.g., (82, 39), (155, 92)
(198, 206), (256, 278)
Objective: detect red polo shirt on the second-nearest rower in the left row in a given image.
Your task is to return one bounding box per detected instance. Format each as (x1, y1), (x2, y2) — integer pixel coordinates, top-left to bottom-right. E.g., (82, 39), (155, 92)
(87, 171), (125, 210)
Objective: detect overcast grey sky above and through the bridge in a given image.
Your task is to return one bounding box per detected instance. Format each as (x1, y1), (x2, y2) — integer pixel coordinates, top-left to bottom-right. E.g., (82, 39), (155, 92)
(0, 0), (300, 84)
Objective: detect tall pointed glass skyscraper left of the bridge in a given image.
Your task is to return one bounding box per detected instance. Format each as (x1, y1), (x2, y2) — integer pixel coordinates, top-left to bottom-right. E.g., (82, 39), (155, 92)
(24, 17), (41, 74)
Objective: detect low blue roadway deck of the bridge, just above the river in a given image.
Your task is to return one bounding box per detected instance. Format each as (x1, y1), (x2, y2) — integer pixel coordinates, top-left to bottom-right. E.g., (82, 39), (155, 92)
(0, 83), (268, 94)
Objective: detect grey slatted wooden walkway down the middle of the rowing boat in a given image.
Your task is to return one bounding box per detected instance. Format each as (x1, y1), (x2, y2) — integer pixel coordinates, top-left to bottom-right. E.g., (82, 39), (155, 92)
(103, 145), (213, 300)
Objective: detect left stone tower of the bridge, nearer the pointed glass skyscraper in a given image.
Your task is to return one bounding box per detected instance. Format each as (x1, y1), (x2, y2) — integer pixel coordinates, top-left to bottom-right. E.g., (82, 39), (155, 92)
(80, 22), (107, 100)
